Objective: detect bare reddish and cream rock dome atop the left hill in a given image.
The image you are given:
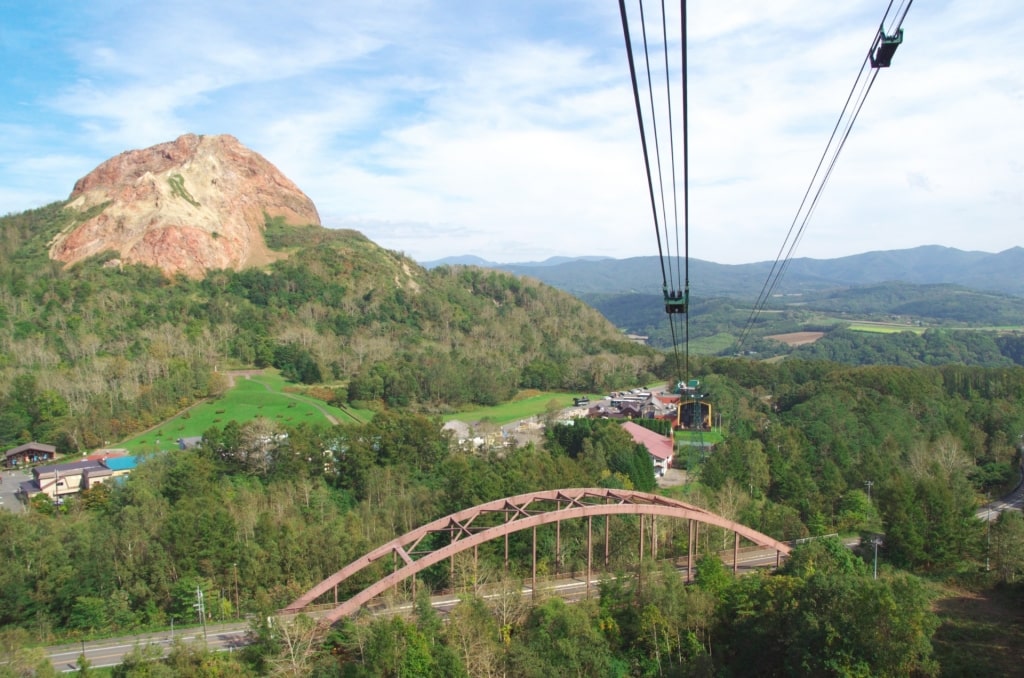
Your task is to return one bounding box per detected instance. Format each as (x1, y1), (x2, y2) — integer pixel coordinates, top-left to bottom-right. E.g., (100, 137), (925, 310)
(50, 134), (321, 278)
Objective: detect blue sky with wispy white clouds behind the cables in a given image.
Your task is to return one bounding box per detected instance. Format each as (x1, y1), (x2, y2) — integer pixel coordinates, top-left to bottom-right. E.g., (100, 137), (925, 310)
(0, 0), (1024, 263)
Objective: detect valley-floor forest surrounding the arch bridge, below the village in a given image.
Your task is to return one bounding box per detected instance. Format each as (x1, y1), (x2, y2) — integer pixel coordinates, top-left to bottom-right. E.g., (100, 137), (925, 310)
(0, 359), (1024, 676)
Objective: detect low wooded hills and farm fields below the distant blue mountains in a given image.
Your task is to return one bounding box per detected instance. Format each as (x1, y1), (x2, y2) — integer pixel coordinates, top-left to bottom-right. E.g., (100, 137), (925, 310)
(581, 283), (1024, 367)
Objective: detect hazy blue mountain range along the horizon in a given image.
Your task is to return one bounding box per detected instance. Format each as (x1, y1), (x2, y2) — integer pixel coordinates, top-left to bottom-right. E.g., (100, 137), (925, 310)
(423, 245), (1024, 299)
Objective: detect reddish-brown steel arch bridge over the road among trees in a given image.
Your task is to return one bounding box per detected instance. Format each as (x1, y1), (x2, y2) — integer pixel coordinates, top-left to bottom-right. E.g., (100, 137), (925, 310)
(282, 488), (790, 624)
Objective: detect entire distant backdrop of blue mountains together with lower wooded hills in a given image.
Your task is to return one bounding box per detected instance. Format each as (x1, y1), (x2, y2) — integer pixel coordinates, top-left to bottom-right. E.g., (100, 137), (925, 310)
(456, 247), (1024, 366)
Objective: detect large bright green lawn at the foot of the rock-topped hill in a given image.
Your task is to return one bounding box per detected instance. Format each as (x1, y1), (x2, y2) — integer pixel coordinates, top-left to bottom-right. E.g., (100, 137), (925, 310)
(116, 370), (373, 453)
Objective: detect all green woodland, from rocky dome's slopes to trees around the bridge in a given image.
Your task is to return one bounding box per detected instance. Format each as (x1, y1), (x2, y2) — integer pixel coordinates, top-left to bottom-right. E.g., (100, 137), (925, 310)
(0, 206), (1024, 677)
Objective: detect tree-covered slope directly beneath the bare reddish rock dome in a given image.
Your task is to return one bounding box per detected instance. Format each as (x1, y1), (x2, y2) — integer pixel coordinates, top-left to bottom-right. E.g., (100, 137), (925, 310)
(0, 203), (662, 451)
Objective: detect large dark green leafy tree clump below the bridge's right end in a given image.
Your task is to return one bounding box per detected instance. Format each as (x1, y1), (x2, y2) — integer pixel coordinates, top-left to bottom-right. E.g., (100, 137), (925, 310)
(722, 551), (938, 677)
